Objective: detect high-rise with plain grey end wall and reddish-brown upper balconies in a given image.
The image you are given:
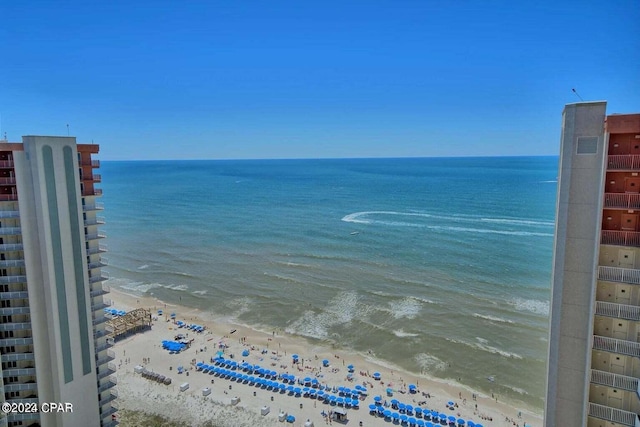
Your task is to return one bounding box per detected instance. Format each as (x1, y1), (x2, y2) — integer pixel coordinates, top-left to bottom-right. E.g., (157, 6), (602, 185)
(545, 102), (640, 427)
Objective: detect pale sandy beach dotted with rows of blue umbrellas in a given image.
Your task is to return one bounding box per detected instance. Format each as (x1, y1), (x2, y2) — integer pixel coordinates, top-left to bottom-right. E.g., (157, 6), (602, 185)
(110, 289), (542, 427)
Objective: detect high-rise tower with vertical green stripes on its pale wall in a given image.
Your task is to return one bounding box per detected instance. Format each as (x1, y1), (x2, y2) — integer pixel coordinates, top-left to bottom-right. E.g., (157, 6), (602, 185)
(0, 136), (117, 427)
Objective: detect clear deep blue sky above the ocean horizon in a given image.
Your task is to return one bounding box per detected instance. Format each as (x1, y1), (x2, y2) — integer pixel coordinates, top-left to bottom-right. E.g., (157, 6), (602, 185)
(0, 0), (640, 160)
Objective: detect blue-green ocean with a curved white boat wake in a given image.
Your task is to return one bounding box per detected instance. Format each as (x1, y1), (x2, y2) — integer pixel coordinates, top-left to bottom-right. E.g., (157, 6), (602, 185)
(100, 157), (558, 411)
